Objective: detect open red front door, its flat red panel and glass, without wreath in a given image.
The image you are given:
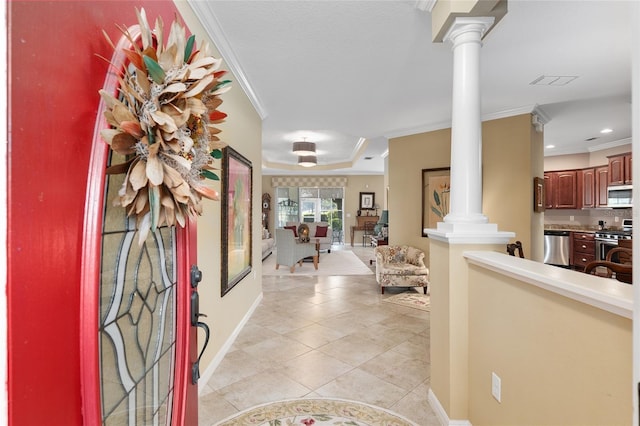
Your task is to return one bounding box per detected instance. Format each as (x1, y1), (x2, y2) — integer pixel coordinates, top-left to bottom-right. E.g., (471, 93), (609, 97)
(6, 0), (197, 426)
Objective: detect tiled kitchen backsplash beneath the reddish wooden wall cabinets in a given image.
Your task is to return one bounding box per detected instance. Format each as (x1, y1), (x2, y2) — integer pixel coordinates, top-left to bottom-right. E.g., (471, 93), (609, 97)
(544, 209), (633, 229)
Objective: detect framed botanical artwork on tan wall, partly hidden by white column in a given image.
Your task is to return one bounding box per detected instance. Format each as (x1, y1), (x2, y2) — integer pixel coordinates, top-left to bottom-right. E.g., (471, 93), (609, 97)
(421, 167), (451, 237)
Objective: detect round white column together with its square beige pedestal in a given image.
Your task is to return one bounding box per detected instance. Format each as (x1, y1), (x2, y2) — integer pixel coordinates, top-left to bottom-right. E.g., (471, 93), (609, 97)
(427, 17), (515, 424)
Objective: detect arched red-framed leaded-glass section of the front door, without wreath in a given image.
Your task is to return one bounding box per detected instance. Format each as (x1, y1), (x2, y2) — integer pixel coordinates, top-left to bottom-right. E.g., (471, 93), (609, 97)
(80, 28), (199, 426)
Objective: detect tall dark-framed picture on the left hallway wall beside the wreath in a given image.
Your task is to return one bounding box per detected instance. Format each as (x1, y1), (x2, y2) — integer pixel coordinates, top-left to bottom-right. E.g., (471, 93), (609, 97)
(221, 146), (253, 296)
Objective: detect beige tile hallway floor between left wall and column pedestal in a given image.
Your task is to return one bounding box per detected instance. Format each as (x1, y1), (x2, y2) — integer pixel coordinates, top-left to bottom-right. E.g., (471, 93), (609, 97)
(199, 246), (439, 426)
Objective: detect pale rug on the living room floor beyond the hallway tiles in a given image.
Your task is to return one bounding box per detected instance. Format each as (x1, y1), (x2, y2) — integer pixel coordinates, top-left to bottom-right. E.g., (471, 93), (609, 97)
(262, 250), (373, 276)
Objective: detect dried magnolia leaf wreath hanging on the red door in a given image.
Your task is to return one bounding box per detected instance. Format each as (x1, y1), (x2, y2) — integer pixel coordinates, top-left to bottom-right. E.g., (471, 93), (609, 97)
(100, 9), (231, 243)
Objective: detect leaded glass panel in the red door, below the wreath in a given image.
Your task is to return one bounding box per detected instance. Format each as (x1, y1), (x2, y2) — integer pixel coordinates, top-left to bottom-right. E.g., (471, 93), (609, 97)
(99, 161), (177, 426)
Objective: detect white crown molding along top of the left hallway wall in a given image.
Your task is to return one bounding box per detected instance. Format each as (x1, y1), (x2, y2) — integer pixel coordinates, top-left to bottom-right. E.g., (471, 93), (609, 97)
(187, 0), (268, 120)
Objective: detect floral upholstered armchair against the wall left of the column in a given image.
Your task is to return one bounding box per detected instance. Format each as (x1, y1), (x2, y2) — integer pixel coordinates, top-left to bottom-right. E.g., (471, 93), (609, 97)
(373, 245), (429, 294)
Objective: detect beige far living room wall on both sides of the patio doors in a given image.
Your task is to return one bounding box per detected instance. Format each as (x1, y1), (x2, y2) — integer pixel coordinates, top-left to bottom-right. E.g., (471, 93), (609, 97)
(262, 175), (384, 244)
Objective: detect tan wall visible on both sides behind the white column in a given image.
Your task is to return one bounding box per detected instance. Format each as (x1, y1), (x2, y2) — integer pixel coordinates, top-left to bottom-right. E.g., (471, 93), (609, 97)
(389, 114), (544, 261)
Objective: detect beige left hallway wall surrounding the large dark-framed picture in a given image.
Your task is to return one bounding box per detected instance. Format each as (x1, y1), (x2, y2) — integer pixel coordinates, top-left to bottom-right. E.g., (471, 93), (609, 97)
(176, 1), (262, 371)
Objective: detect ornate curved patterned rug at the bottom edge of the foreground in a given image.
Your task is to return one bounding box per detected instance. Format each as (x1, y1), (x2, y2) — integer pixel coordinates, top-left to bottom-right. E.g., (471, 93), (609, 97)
(215, 398), (418, 426)
